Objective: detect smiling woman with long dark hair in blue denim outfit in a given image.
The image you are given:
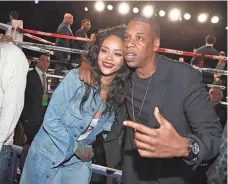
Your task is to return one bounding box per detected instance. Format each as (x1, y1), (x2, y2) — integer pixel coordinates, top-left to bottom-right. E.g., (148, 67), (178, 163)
(20, 27), (129, 184)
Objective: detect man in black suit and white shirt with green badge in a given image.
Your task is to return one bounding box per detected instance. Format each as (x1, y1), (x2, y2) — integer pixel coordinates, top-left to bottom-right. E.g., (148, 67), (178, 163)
(20, 54), (50, 170)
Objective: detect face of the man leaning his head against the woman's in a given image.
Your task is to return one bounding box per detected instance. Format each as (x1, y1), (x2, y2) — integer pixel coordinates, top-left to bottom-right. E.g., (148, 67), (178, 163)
(124, 21), (158, 68)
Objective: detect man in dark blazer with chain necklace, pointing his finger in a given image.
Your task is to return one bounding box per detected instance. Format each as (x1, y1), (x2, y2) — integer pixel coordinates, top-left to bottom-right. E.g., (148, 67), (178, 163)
(80, 17), (222, 184)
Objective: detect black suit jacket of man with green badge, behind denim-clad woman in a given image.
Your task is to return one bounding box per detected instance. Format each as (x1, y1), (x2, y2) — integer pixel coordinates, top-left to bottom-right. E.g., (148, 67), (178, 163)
(20, 69), (46, 144)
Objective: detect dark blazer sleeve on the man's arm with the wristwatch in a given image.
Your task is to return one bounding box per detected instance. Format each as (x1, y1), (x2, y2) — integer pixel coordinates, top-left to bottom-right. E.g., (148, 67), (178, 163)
(183, 69), (222, 167)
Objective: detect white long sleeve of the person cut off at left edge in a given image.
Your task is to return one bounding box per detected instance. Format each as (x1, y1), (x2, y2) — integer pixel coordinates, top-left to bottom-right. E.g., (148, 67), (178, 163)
(0, 44), (28, 150)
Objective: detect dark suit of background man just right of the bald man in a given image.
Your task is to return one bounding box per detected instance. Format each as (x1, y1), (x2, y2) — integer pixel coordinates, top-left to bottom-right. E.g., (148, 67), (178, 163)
(71, 29), (88, 64)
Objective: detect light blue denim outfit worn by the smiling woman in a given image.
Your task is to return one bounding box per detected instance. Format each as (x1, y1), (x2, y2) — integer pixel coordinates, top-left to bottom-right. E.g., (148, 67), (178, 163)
(20, 70), (115, 184)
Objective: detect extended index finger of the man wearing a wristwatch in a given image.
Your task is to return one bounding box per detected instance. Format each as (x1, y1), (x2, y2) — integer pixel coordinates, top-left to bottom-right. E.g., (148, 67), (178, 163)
(123, 121), (155, 135)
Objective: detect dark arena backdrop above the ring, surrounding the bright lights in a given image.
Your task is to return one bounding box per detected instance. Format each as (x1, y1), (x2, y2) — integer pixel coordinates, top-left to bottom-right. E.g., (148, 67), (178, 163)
(0, 1), (227, 61)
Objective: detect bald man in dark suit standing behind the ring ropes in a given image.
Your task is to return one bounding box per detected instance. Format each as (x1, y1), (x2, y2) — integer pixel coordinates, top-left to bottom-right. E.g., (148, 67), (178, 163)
(51, 13), (74, 90)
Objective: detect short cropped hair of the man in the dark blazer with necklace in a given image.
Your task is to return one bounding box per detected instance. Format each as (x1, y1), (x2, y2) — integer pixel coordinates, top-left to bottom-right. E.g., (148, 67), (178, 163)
(131, 16), (160, 38)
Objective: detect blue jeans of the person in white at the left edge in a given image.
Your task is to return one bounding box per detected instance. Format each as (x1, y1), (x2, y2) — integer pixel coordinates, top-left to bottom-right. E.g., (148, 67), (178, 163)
(0, 145), (12, 184)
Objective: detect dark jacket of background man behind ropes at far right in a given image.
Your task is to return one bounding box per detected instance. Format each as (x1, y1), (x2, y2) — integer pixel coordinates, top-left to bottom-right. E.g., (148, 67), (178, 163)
(191, 45), (219, 84)
